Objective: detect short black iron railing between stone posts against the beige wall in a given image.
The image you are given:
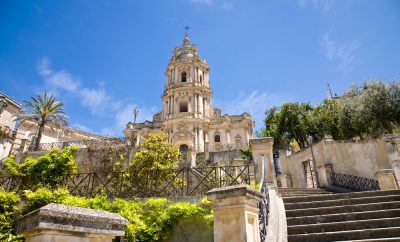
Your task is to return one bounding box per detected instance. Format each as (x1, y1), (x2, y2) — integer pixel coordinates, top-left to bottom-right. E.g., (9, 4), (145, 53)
(332, 172), (380, 191)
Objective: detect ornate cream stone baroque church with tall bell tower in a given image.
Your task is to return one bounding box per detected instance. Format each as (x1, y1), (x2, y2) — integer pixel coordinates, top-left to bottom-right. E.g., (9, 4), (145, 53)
(124, 32), (254, 164)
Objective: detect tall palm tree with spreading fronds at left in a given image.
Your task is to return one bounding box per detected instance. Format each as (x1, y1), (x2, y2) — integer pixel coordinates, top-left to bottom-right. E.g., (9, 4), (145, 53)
(17, 92), (68, 151)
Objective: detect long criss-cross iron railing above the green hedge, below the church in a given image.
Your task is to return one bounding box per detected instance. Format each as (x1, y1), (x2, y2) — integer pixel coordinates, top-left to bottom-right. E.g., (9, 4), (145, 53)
(0, 165), (253, 198)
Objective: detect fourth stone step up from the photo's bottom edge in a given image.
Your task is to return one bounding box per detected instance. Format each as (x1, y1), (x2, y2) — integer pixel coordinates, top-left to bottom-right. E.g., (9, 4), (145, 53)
(286, 201), (400, 218)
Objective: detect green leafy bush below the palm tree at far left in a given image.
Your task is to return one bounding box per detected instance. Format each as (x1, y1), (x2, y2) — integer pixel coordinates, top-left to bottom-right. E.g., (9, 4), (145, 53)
(5, 146), (78, 188)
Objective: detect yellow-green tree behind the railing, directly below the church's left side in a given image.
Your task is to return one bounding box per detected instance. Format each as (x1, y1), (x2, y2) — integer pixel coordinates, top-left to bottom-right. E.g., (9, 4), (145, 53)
(129, 132), (181, 193)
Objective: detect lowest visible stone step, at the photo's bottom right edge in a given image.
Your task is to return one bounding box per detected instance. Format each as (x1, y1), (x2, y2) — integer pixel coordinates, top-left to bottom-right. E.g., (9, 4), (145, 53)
(288, 227), (400, 242)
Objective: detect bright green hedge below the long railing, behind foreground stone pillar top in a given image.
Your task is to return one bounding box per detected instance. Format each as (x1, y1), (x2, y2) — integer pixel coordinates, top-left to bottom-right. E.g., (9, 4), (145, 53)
(18, 188), (213, 241)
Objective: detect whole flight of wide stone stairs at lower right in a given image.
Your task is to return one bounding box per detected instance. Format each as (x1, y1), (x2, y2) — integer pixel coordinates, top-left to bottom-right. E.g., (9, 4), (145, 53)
(279, 188), (400, 242)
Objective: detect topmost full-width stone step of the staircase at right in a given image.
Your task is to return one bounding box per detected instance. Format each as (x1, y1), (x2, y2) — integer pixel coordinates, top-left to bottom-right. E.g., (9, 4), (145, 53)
(283, 190), (400, 204)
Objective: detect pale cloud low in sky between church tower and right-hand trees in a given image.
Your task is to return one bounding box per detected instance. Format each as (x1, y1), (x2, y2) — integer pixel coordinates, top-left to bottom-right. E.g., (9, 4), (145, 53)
(214, 90), (288, 130)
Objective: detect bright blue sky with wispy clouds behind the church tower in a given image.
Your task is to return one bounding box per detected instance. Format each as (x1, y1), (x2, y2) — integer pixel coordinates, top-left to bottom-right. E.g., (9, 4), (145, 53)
(0, 0), (400, 136)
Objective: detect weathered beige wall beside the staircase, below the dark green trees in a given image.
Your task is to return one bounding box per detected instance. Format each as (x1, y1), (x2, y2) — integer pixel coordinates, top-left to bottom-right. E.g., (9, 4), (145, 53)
(280, 138), (392, 187)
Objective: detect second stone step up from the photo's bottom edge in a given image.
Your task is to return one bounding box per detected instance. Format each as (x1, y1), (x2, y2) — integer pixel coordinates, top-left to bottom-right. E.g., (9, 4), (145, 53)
(287, 217), (400, 235)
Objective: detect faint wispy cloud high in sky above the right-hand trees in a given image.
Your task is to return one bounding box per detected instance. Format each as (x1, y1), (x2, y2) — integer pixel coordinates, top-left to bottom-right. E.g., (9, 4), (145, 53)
(321, 33), (360, 72)
